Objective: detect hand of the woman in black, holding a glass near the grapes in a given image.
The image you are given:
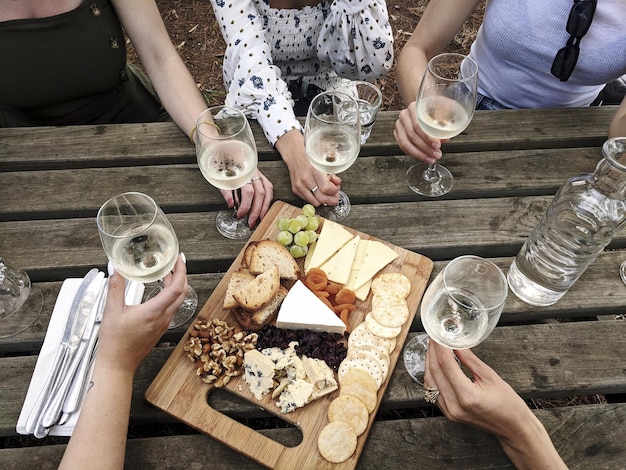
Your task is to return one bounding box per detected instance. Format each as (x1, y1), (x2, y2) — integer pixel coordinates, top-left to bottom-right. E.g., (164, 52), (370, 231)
(220, 170), (274, 228)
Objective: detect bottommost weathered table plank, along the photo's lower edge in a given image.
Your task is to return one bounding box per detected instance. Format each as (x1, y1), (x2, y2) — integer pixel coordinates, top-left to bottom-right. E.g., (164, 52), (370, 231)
(0, 404), (626, 470)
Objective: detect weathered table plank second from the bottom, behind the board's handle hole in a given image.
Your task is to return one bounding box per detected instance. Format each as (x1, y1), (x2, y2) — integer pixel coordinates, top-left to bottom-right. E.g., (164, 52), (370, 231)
(0, 320), (626, 436)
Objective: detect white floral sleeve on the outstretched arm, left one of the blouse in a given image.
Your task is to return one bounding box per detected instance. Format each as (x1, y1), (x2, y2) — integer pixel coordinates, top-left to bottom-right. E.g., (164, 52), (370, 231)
(211, 0), (302, 145)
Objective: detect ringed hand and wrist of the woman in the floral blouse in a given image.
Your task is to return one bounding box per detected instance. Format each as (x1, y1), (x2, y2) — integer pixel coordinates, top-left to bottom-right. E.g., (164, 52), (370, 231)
(275, 130), (341, 207)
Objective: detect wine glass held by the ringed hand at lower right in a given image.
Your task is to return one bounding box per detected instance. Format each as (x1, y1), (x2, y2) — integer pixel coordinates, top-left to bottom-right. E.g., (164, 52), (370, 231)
(404, 255), (508, 385)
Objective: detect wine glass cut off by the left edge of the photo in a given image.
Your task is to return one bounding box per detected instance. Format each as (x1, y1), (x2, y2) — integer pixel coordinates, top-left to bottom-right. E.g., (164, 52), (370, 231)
(0, 256), (43, 338)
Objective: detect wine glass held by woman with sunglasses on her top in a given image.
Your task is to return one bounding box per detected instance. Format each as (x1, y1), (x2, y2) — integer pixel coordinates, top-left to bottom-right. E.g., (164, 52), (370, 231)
(406, 53), (478, 197)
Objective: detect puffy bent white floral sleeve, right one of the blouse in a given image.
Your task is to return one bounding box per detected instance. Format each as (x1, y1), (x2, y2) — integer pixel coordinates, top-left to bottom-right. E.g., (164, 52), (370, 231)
(317, 0), (393, 82)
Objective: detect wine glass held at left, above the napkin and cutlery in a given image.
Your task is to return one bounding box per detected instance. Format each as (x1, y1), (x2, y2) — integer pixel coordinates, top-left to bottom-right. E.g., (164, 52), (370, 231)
(96, 192), (198, 329)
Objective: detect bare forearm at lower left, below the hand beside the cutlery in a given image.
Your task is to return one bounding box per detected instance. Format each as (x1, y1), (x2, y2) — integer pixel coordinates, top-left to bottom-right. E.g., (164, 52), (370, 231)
(59, 363), (133, 469)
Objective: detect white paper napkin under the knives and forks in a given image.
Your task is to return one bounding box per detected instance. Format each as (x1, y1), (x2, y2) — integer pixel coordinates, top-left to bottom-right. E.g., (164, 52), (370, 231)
(16, 278), (145, 436)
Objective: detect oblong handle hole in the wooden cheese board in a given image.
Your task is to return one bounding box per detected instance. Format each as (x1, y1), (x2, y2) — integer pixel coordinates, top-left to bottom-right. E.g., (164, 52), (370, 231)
(207, 387), (303, 447)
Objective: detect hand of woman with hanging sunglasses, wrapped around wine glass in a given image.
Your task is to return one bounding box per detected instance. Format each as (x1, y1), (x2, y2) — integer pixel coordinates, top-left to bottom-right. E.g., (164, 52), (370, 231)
(393, 101), (448, 163)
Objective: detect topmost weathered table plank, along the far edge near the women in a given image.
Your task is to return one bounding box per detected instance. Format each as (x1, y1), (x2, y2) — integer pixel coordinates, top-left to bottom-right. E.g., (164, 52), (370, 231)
(0, 106), (616, 171)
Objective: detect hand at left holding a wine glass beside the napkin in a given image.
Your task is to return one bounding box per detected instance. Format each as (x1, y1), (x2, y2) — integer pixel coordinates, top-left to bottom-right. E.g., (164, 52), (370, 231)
(98, 255), (189, 376)
